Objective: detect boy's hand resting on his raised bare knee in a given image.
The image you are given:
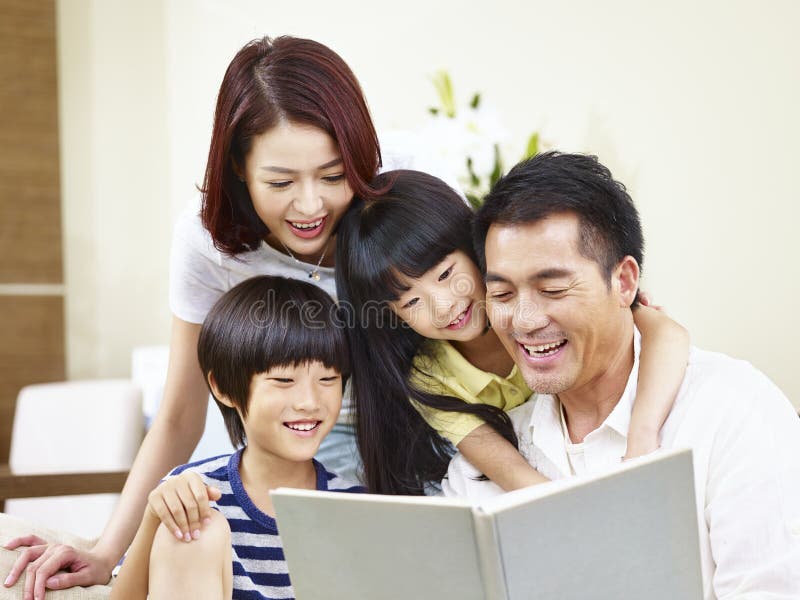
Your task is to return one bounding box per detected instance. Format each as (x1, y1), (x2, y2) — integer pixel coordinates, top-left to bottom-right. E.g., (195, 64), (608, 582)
(147, 471), (222, 542)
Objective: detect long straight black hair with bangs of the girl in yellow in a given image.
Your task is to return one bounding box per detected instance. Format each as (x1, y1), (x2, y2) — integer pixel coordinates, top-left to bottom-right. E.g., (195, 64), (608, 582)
(336, 171), (517, 495)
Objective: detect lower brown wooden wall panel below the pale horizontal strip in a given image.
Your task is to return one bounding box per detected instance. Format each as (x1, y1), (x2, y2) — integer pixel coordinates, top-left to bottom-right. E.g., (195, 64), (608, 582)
(0, 296), (65, 463)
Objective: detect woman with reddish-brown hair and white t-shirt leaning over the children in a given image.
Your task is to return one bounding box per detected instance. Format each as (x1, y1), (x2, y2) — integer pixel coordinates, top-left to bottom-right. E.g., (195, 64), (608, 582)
(6, 37), (440, 600)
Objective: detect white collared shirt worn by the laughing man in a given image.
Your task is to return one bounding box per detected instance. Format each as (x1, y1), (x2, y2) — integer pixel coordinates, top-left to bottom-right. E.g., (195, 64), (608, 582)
(442, 331), (800, 599)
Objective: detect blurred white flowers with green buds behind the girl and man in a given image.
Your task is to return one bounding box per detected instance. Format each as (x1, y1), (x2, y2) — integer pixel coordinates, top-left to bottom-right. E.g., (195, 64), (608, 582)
(422, 71), (539, 208)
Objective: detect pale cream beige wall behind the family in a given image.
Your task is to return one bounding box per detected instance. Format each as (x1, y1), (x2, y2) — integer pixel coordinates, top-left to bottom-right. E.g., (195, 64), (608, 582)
(59, 0), (800, 406)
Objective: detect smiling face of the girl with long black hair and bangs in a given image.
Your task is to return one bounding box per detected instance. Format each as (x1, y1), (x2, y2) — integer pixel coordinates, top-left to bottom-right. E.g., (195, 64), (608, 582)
(392, 250), (487, 342)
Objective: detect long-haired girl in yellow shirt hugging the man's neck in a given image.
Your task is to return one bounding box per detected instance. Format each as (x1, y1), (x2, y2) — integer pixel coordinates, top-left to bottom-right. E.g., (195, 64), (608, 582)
(336, 171), (689, 494)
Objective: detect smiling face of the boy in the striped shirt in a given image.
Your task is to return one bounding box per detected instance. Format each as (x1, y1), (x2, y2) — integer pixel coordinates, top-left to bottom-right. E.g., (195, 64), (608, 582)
(242, 361), (342, 462)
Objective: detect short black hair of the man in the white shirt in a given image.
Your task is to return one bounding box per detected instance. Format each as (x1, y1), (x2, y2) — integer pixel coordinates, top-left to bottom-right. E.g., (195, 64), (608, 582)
(473, 151), (644, 292)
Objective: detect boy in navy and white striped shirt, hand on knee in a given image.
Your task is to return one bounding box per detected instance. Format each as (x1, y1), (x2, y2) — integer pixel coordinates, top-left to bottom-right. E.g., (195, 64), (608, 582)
(111, 276), (363, 600)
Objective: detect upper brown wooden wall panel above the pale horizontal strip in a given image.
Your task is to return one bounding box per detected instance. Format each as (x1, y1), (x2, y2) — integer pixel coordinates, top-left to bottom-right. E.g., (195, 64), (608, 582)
(0, 0), (62, 283)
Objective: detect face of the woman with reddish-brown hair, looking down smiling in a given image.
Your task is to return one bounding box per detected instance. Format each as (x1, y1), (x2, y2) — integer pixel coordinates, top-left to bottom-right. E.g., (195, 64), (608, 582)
(240, 122), (353, 264)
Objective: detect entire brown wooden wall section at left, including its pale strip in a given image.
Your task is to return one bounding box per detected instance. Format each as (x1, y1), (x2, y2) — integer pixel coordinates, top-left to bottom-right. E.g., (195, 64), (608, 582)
(0, 0), (65, 478)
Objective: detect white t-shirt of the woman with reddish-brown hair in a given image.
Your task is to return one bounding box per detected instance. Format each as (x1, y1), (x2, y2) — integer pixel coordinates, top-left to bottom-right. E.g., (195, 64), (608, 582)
(169, 132), (457, 423)
